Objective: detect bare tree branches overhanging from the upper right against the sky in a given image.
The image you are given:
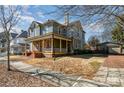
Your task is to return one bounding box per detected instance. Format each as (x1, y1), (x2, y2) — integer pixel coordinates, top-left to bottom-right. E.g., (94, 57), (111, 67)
(46, 5), (124, 39)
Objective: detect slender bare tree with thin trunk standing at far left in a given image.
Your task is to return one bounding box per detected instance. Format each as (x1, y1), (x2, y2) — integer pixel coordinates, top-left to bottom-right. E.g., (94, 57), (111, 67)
(0, 5), (21, 71)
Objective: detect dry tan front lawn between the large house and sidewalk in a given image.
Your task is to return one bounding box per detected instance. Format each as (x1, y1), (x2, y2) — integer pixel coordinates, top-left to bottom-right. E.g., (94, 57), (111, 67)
(25, 57), (101, 79)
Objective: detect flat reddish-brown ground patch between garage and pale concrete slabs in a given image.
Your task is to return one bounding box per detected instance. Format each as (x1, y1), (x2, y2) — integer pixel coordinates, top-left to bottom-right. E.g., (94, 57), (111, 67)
(103, 55), (124, 68)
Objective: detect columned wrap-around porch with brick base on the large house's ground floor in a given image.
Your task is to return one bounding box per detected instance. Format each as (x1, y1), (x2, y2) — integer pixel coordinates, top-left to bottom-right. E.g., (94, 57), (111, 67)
(25, 33), (72, 58)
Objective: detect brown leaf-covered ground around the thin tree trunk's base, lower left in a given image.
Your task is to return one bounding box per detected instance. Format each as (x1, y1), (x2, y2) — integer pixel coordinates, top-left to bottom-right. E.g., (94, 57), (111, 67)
(0, 64), (53, 87)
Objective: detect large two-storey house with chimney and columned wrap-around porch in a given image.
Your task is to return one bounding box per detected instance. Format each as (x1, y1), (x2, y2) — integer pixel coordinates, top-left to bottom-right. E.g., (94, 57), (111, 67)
(26, 16), (85, 58)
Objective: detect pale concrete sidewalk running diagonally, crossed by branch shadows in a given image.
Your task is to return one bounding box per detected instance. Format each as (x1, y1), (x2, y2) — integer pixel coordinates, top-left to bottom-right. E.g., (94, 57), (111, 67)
(11, 62), (109, 87)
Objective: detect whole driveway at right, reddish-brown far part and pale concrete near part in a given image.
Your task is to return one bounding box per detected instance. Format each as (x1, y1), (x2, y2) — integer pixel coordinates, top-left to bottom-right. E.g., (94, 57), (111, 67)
(93, 55), (124, 87)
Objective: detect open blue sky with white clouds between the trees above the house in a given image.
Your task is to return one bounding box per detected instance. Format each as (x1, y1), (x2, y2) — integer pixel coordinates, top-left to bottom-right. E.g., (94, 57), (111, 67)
(7, 5), (104, 41)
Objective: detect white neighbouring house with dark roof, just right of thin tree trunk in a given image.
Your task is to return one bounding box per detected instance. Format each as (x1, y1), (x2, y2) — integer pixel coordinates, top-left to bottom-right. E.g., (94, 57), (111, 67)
(10, 30), (29, 54)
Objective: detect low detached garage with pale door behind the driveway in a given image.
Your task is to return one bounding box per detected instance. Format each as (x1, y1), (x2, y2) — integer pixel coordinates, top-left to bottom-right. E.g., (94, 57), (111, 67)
(97, 42), (122, 54)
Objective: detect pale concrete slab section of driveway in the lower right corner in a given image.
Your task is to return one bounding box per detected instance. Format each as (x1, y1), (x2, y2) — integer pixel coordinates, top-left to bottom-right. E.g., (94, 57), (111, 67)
(93, 66), (124, 87)
